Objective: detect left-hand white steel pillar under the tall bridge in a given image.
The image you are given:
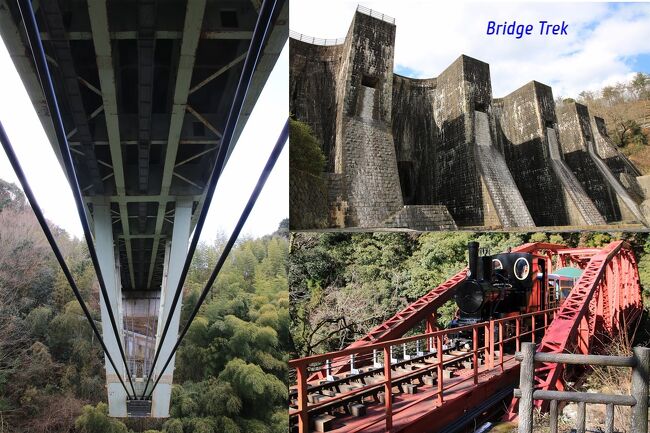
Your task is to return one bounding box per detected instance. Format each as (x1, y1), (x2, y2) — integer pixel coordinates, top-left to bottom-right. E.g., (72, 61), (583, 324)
(93, 204), (129, 417)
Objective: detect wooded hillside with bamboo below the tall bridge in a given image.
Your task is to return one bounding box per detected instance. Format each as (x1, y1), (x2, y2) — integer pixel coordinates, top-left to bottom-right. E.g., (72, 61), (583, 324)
(0, 181), (291, 433)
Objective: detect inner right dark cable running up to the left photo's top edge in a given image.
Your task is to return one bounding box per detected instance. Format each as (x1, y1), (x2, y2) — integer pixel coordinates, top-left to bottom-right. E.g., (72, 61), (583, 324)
(142, 0), (285, 398)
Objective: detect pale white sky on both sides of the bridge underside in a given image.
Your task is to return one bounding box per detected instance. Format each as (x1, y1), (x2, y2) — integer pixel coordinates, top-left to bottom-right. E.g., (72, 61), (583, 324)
(0, 35), (289, 242)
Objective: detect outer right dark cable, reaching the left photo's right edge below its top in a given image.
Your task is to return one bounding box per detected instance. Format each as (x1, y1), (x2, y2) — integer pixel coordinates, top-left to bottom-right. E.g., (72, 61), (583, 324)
(145, 120), (289, 396)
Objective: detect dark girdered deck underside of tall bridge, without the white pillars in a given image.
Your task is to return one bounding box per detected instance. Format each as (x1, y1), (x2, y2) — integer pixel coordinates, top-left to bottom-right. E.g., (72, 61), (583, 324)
(0, 0), (288, 290)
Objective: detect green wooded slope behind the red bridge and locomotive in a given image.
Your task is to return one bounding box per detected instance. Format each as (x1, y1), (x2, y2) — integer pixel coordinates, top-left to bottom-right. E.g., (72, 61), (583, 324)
(289, 232), (650, 356)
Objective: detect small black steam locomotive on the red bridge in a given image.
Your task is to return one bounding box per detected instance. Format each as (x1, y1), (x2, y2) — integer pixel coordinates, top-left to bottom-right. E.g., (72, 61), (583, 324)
(450, 242), (568, 347)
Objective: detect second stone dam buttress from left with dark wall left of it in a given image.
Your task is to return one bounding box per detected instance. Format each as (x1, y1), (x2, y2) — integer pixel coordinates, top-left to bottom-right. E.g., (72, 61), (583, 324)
(392, 56), (534, 227)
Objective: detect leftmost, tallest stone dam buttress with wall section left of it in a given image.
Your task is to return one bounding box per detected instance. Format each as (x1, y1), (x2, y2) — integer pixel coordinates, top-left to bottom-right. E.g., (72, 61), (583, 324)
(291, 8), (450, 227)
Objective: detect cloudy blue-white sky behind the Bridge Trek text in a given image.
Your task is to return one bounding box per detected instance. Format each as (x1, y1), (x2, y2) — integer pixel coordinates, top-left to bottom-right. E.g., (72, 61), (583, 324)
(290, 0), (650, 97)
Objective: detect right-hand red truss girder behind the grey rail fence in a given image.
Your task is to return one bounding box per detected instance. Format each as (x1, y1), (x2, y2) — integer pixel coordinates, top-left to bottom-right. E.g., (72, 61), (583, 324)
(535, 241), (642, 396)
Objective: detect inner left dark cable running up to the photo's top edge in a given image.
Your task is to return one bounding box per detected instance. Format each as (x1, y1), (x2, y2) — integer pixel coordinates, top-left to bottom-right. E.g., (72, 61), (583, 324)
(18, 0), (136, 396)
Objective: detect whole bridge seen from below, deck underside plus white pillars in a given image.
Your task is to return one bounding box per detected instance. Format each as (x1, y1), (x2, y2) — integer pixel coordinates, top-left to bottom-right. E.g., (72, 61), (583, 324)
(0, 0), (288, 416)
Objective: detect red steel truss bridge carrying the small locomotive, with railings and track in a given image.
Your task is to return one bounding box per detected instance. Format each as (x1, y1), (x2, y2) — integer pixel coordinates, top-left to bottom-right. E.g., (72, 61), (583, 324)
(289, 241), (642, 433)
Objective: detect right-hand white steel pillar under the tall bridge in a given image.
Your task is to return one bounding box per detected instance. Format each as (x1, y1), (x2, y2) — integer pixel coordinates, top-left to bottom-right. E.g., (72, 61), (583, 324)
(150, 201), (192, 418)
